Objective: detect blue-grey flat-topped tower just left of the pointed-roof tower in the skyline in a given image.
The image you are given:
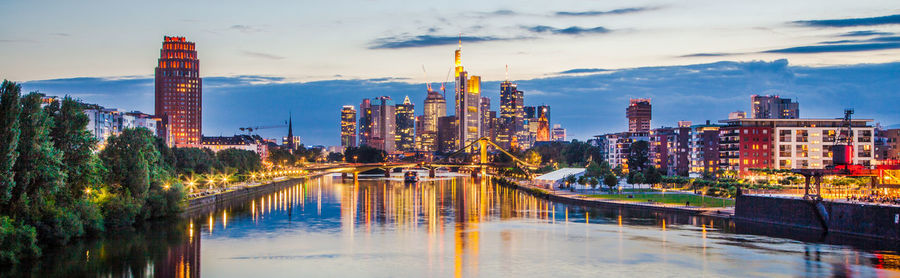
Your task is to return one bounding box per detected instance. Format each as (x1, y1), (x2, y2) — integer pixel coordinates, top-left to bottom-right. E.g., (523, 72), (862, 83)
(369, 96), (397, 153)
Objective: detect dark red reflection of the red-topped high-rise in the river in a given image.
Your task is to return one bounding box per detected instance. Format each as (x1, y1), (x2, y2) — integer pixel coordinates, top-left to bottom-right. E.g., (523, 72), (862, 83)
(153, 221), (201, 278)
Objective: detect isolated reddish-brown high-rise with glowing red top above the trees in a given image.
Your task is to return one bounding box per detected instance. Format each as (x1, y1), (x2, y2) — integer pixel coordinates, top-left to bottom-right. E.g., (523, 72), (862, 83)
(156, 36), (203, 147)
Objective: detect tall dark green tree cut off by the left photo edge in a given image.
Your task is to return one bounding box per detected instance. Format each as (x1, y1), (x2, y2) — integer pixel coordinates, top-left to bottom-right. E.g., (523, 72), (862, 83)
(0, 80), (22, 206)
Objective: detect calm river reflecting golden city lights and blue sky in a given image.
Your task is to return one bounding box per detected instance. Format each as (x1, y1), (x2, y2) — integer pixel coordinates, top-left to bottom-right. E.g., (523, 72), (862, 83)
(7, 177), (900, 277)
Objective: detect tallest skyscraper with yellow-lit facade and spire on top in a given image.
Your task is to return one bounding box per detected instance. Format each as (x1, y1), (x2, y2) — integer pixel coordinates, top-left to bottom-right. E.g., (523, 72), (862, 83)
(455, 42), (481, 151)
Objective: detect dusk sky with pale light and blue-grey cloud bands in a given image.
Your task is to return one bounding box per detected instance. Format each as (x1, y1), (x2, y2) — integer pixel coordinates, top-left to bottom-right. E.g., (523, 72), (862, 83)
(0, 0), (900, 145)
